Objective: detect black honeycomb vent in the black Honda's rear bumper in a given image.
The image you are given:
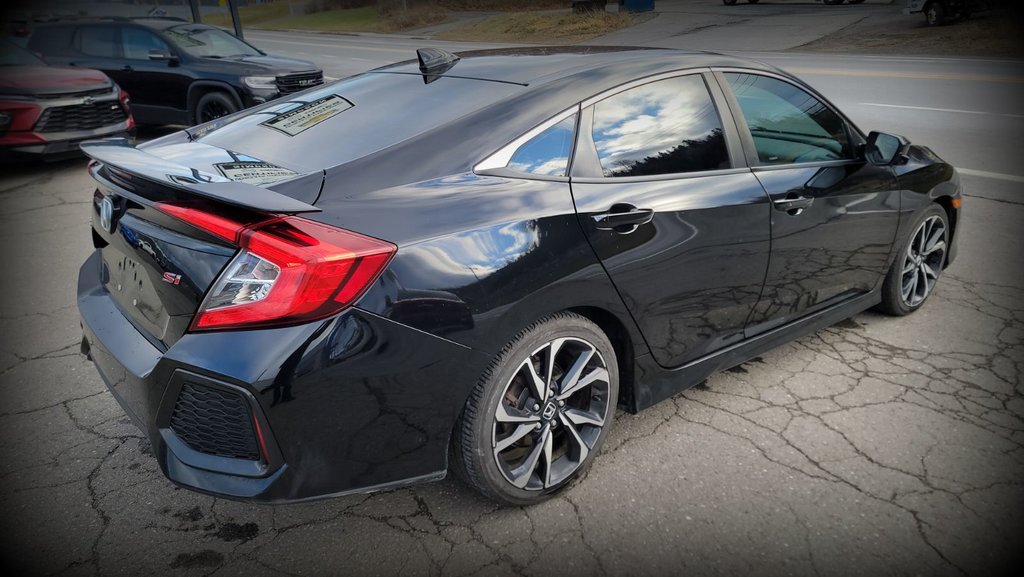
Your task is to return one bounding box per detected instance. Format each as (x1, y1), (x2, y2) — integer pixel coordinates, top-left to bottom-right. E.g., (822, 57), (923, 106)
(170, 382), (260, 461)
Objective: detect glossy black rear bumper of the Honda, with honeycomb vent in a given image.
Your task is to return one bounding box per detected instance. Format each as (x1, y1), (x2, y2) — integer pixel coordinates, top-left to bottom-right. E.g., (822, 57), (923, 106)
(78, 252), (488, 502)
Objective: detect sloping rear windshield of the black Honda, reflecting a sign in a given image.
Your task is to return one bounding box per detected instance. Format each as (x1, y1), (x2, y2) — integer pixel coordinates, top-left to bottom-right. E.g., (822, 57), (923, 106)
(194, 73), (523, 172)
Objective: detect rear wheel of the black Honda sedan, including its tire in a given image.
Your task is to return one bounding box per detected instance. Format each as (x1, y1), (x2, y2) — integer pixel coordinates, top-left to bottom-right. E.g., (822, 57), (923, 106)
(452, 313), (618, 505)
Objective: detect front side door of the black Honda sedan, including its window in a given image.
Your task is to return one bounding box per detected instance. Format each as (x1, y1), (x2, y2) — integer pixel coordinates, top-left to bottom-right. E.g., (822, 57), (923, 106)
(719, 71), (899, 336)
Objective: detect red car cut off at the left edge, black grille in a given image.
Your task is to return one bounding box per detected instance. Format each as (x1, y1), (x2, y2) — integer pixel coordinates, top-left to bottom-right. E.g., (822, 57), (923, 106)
(0, 40), (135, 160)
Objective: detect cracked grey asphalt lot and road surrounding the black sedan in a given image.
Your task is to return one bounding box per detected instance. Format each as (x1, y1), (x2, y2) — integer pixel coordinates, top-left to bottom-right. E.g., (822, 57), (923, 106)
(0, 15), (1024, 577)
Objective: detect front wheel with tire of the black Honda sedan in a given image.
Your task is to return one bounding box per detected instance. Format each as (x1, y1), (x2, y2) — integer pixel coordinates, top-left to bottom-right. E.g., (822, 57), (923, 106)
(878, 204), (949, 317)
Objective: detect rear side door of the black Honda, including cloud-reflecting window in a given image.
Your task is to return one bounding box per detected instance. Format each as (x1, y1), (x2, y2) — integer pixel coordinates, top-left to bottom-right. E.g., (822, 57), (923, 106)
(571, 73), (770, 367)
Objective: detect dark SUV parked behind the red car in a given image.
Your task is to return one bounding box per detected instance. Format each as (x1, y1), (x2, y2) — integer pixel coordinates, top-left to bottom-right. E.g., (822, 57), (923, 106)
(29, 18), (324, 124)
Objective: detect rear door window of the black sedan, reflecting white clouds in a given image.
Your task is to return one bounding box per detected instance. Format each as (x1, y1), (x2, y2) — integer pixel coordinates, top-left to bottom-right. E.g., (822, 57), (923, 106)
(594, 75), (729, 176)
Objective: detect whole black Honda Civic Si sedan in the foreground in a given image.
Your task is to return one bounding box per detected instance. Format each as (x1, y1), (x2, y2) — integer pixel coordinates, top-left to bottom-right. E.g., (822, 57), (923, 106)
(78, 48), (962, 504)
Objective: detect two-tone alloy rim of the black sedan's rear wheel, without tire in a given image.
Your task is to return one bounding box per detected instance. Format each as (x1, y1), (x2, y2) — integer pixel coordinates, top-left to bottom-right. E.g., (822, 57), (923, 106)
(492, 338), (611, 491)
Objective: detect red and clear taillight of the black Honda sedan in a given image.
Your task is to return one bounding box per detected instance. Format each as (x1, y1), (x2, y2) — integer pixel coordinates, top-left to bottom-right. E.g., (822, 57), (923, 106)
(158, 203), (397, 331)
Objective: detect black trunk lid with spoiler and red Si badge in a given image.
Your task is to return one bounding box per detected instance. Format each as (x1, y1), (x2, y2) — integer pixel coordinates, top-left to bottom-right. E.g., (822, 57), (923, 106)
(82, 138), (323, 349)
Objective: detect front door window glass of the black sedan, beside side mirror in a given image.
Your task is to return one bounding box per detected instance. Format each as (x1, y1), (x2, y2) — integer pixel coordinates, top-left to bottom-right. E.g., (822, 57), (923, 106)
(725, 73), (853, 164)
